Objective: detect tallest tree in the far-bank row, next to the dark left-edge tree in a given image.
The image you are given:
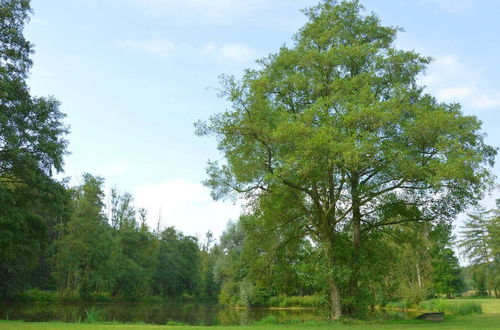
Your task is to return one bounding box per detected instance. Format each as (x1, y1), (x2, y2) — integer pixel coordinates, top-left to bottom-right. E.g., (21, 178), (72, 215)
(54, 174), (116, 299)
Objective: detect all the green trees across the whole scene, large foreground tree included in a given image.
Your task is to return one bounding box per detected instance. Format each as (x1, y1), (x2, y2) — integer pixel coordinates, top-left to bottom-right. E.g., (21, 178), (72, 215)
(0, 0), (500, 319)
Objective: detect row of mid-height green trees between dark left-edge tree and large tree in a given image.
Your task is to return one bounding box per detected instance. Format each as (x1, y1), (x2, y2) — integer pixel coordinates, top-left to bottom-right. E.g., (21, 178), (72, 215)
(53, 174), (219, 300)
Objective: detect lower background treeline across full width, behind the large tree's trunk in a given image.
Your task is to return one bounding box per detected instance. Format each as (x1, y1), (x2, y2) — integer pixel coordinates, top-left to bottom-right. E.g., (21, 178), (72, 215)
(1, 174), (499, 307)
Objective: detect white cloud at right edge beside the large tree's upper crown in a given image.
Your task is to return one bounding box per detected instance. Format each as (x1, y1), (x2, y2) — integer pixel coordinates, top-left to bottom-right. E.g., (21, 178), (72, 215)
(419, 55), (500, 109)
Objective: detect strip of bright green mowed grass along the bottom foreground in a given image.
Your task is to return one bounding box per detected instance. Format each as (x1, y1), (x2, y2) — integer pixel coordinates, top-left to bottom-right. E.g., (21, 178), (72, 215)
(0, 299), (500, 330)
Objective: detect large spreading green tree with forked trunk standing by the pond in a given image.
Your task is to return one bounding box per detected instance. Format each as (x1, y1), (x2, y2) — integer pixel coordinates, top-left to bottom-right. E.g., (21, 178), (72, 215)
(197, 0), (496, 319)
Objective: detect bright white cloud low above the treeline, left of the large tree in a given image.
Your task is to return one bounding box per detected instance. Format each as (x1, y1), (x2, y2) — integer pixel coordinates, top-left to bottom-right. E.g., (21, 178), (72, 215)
(133, 179), (240, 237)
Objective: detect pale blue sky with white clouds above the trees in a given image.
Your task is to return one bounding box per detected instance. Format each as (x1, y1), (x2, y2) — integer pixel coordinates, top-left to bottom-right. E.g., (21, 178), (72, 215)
(25, 0), (500, 237)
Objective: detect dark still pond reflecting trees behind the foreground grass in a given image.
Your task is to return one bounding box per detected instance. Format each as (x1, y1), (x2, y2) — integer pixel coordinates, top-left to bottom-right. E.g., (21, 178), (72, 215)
(0, 302), (422, 325)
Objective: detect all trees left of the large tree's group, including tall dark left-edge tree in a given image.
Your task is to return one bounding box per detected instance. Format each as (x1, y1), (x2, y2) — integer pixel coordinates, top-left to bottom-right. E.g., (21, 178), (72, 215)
(0, 0), (217, 300)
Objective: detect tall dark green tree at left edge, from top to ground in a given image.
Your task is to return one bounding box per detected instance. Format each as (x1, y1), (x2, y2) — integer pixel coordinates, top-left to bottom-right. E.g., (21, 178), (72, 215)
(0, 0), (68, 297)
